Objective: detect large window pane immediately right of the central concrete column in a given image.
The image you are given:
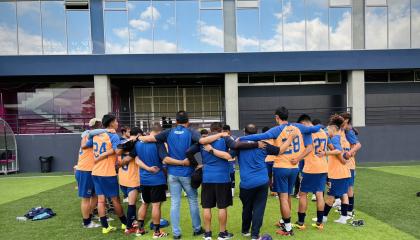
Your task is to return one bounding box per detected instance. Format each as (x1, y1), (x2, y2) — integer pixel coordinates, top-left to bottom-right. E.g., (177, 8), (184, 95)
(236, 8), (260, 52)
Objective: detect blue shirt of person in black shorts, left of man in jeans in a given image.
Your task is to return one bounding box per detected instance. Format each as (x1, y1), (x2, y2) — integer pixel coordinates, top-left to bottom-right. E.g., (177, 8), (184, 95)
(130, 141), (166, 186)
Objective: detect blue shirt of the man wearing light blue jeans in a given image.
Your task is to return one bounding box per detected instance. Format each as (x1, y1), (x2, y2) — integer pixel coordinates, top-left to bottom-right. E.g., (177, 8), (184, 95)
(155, 125), (201, 177)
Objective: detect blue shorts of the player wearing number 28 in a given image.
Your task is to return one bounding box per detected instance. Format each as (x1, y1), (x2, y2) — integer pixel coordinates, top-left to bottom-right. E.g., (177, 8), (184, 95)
(273, 168), (299, 195)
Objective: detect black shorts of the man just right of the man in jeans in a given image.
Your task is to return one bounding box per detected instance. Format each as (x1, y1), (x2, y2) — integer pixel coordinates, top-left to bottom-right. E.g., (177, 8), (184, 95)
(201, 182), (232, 209)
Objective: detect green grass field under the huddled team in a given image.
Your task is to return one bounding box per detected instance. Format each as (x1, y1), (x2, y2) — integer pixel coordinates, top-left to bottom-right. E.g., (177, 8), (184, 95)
(0, 162), (420, 240)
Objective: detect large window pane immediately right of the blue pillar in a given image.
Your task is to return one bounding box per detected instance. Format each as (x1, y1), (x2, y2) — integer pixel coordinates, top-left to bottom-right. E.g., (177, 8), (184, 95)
(104, 10), (129, 53)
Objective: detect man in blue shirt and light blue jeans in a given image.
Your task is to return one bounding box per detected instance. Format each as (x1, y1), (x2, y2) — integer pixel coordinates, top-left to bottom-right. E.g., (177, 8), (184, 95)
(139, 111), (204, 239)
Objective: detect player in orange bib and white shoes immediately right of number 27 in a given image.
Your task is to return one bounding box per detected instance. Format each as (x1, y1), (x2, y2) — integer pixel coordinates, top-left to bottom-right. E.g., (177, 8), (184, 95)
(319, 115), (351, 224)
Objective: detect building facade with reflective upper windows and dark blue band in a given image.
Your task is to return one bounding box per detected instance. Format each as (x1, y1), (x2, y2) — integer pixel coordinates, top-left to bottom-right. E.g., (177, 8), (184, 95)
(0, 0), (420, 170)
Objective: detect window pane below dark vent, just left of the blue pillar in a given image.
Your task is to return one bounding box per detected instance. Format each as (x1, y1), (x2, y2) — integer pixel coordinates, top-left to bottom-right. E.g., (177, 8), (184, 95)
(67, 10), (92, 54)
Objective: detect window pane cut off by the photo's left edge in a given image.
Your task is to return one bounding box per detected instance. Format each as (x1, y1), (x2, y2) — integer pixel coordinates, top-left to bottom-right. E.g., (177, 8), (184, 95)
(0, 2), (18, 55)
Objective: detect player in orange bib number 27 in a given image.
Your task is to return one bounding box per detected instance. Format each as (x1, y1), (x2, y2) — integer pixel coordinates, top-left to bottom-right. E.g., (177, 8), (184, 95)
(294, 114), (328, 230)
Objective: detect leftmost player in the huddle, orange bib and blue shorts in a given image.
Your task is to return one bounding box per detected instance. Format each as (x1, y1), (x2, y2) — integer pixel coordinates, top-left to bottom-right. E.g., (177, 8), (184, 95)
(75, 118), (102, 228)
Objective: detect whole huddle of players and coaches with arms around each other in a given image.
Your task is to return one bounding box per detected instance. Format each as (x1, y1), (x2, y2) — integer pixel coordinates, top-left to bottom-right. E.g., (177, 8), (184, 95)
(75, 107), (361, 240)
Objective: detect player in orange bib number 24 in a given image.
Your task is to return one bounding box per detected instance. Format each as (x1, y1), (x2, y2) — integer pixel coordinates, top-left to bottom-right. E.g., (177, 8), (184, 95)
(86, 114), (127, 234)
